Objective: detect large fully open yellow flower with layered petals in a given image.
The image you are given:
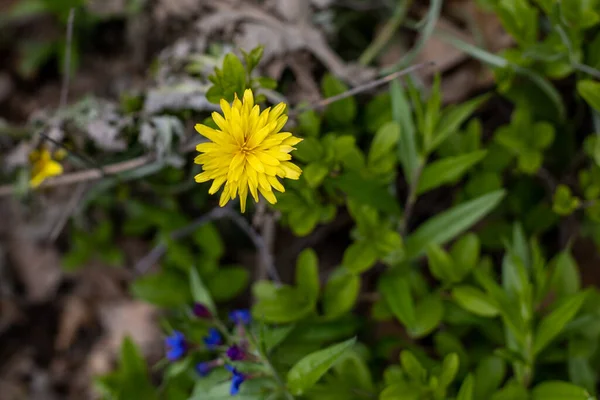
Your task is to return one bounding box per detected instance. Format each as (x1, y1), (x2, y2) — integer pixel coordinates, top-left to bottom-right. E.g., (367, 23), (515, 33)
(194, 89), (302, 212)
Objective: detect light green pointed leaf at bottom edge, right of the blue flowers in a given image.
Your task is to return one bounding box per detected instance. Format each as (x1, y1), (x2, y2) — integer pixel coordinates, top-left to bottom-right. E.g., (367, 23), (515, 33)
(286, 338), (356, 395)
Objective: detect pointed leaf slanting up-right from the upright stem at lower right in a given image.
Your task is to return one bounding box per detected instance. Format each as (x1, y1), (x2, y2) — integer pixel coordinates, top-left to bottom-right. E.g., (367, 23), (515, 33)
(533, 292), (588, 355)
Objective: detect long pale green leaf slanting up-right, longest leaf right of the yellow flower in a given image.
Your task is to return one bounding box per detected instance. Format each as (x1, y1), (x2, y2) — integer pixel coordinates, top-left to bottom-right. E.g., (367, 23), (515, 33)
(405, 190), (506, 260)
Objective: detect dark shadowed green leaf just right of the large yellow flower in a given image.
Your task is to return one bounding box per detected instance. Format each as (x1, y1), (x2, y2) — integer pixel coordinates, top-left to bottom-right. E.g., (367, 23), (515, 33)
(332, 171), (400, 215)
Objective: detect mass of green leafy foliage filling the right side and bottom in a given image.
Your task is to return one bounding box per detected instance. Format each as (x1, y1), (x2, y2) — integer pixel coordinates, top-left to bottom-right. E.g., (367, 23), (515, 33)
(21, 0), (600, 400)
